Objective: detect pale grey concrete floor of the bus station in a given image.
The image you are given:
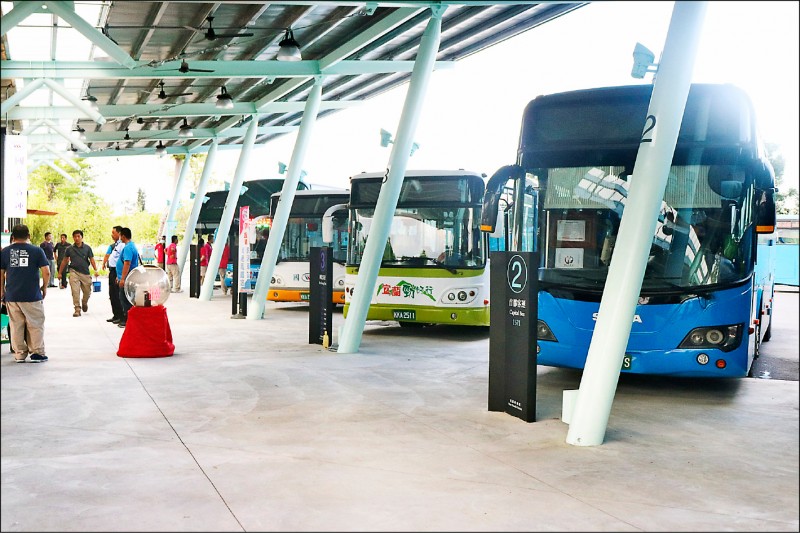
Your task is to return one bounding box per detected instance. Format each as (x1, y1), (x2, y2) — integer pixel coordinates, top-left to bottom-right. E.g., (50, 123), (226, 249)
(0, 282), (800, 532)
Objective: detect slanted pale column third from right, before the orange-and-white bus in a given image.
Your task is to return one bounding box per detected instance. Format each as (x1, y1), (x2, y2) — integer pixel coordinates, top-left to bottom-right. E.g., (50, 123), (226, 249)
(247, 77), (322, 320)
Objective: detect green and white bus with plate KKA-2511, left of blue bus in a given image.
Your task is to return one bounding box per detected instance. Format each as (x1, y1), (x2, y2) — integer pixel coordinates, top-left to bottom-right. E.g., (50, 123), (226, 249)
(344, 170), (489, 326)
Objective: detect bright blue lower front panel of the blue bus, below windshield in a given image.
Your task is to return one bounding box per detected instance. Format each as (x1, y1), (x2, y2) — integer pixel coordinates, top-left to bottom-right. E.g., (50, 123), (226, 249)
(538, 285), (753, 378)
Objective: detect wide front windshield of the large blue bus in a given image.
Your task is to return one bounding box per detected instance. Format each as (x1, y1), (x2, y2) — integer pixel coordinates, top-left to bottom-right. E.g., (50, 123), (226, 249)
(529, 165), (756, 292)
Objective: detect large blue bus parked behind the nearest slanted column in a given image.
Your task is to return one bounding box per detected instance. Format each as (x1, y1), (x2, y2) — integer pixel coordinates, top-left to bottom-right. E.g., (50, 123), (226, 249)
(482, 84), (776, 378)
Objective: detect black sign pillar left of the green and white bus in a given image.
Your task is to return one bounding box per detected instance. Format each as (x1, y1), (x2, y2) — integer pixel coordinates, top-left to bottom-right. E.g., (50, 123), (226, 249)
(308, 246), (333, 347)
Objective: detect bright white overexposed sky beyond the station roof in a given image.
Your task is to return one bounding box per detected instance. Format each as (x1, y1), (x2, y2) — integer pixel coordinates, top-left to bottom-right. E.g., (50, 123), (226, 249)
(83, 1), (800, 211)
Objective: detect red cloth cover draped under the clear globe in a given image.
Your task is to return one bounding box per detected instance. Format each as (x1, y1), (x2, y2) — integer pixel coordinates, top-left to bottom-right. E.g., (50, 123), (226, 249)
(117, 305), (175, 357)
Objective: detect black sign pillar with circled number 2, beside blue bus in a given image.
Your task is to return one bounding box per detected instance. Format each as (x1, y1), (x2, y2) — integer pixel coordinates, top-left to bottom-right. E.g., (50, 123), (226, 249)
(489, 252), (539, 422)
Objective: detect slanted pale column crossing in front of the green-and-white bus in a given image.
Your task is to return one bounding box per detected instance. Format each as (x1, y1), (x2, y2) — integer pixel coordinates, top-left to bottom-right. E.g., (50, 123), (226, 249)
(337, 6), (446, 353)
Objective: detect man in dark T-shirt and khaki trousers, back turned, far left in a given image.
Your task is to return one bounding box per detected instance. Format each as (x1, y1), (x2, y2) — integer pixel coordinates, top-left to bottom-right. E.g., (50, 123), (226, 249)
(0, 224), (50, 363)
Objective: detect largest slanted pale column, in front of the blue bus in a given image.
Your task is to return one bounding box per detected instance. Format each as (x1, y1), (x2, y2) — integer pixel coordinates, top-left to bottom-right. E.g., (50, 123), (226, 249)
(567, 2), (707, 446)
